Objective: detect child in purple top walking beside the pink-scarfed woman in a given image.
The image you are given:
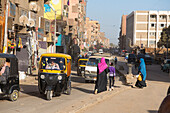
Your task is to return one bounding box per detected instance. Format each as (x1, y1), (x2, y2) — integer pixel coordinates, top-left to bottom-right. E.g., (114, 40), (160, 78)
(109, 62), (116, 91)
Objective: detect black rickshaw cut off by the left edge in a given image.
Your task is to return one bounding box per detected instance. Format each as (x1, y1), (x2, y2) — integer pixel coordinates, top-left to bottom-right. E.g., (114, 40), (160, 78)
(0, 53), (20, 101)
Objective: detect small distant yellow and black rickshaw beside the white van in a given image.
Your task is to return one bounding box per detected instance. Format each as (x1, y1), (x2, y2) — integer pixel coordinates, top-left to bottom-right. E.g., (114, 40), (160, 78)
(77, 58), (88, 76)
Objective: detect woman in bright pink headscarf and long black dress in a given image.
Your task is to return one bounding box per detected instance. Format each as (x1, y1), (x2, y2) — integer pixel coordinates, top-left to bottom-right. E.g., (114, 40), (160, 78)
(95, 57), (108, 94)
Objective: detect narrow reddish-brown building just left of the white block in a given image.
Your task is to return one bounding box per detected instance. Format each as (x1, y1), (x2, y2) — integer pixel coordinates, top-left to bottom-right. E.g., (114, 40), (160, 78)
(118, 15), (127, 50)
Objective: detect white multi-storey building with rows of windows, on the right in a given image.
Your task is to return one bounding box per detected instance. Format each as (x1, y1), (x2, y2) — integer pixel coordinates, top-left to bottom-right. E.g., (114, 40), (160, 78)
(126, 11), (170, 49)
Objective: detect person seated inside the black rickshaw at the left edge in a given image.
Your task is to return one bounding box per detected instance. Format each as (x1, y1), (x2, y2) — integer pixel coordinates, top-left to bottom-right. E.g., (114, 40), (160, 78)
(0, 58), (10, 82)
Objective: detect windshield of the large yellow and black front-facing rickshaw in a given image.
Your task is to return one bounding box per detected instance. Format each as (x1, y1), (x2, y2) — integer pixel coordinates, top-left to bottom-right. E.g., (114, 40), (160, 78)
(41, 57), (66, 70)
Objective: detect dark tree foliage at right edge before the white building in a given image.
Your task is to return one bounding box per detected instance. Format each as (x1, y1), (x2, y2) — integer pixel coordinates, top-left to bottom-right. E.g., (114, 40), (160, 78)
(157, 26), (170, 48)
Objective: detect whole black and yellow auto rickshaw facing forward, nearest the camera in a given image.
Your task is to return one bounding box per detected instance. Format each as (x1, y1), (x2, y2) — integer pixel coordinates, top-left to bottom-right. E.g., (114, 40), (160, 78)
(38, 53), (71, 100)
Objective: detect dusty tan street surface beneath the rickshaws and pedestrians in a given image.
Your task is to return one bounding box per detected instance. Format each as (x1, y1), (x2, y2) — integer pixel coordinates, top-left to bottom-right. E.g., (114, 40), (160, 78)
(0, 55), (170, 113)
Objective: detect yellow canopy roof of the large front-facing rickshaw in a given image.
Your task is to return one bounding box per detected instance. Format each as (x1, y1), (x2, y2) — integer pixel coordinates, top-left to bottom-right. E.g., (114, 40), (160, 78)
(41, 53), (71, 59)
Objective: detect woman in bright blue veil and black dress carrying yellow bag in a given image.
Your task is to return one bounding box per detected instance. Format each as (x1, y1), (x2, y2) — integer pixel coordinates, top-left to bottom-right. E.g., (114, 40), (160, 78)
(135, 58), (146, 88)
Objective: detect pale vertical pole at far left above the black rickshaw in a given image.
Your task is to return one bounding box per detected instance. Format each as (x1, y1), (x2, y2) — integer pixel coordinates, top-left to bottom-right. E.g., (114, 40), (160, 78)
(3, 0), (9, 53)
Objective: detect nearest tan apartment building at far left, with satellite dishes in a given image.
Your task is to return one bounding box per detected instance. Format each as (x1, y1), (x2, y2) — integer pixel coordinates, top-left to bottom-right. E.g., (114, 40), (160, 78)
(0, 0), (44, 74)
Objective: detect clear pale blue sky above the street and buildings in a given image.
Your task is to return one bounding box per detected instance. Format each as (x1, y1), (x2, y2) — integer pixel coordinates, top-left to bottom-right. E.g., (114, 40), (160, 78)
(87, 0), (170, 44)
